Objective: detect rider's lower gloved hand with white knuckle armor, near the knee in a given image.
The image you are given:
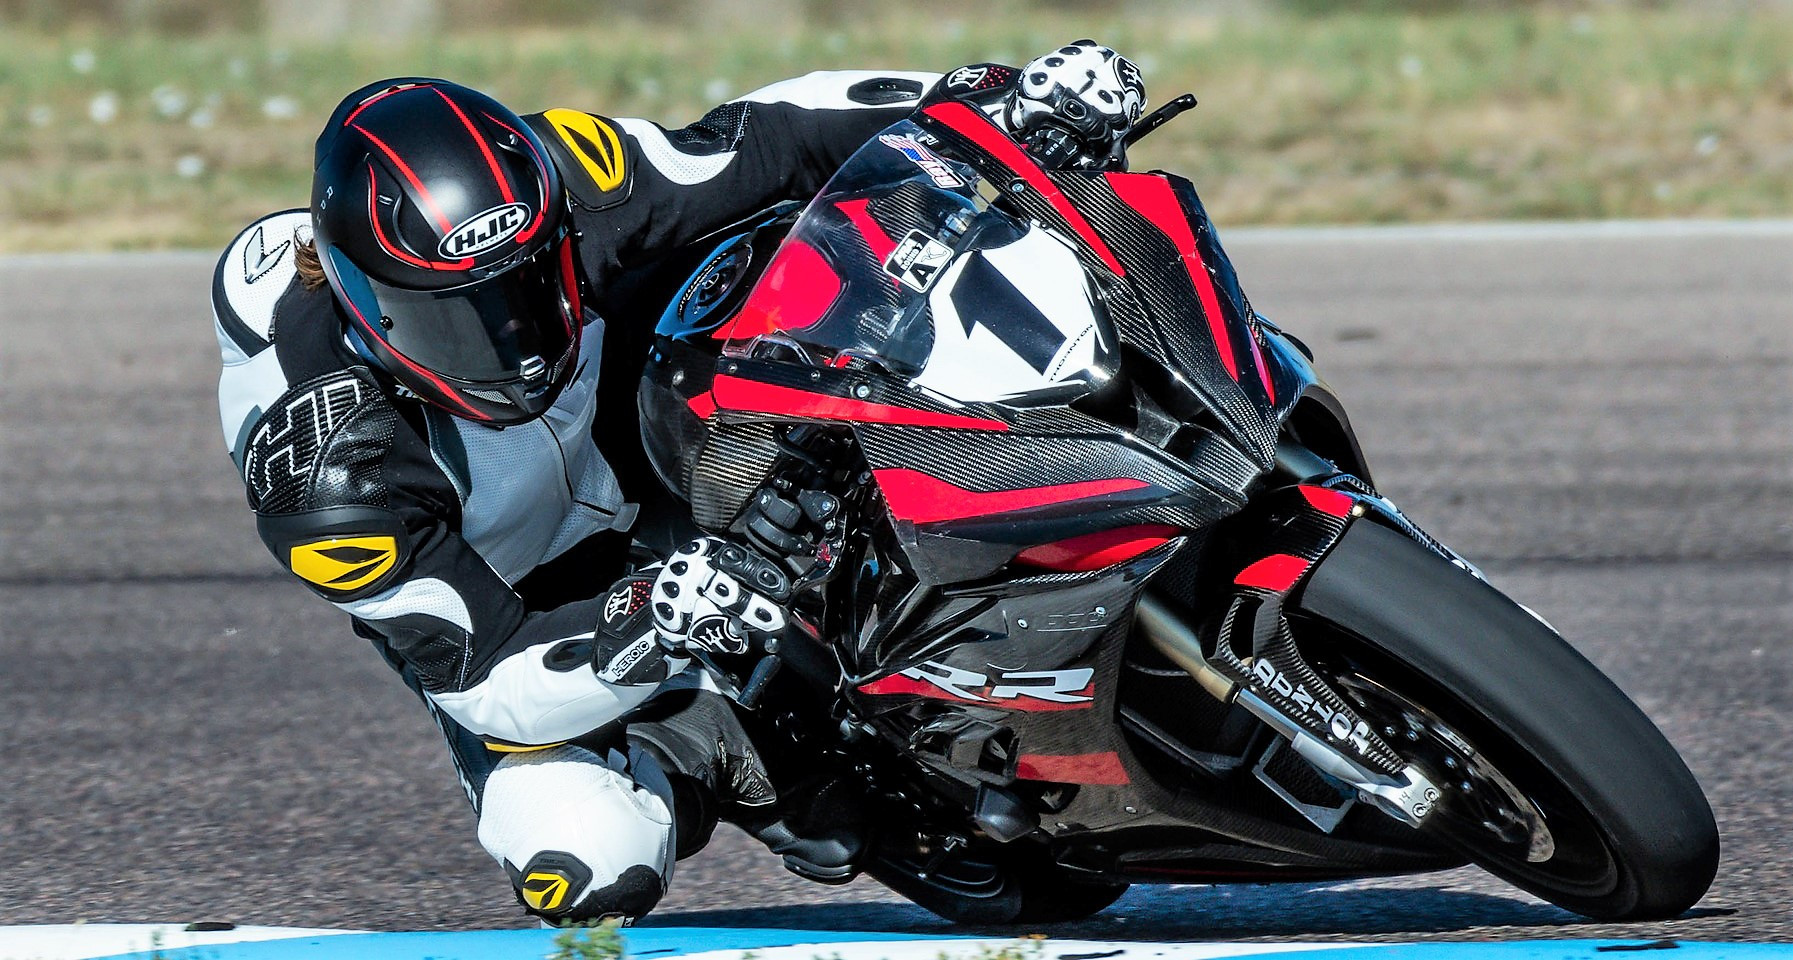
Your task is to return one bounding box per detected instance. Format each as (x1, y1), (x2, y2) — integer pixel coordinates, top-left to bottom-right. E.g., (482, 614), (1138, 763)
(653, 537), (791, 653)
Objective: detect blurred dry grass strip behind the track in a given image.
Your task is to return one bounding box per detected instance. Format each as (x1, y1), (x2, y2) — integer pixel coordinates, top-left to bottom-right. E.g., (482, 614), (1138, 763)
(0, 0), (1793, 253)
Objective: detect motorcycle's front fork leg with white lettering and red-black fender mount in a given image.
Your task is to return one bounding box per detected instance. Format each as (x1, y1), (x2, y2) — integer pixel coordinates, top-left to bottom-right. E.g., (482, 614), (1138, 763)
(1137, 483), (1440, 827)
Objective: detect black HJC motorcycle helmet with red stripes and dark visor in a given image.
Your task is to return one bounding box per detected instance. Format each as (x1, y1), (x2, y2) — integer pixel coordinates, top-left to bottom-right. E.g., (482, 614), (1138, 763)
(312, 77), (583, 425)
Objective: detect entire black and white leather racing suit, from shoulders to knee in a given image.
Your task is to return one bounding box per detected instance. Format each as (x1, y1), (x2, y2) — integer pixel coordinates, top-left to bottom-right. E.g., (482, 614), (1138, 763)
(212, 72), (938, 921)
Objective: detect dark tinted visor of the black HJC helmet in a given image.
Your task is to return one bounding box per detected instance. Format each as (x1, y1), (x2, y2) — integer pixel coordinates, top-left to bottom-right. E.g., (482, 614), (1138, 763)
(366, 233), (579, 384)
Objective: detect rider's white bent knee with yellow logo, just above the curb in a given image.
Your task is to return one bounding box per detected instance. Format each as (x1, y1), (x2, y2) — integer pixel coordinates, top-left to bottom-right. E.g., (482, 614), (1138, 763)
(479, 746), (672, 922)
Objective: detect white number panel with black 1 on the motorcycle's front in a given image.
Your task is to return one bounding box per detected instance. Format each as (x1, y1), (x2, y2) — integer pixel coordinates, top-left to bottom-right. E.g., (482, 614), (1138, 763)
(914, 224), (1112, 404)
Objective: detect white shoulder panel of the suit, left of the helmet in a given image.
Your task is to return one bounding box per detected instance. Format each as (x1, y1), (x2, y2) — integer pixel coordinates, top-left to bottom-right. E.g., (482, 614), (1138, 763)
(212, 210), (312, 362)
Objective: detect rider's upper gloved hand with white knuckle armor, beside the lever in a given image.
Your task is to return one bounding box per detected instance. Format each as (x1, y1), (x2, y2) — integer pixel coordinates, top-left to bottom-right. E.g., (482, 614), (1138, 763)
(1004, 39), (1146, 167)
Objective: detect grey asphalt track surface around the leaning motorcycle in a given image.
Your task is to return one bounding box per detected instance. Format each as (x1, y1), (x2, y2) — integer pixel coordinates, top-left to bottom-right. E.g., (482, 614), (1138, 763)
(0, 224), (1793, 940)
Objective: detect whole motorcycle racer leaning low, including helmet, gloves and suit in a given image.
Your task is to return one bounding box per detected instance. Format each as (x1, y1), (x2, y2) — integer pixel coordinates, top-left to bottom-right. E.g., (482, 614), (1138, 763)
(212, 41), (1144, 922)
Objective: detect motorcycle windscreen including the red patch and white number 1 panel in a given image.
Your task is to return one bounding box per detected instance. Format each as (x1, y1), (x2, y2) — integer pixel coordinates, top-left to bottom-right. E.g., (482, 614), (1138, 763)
(717, 120), (1113, 404)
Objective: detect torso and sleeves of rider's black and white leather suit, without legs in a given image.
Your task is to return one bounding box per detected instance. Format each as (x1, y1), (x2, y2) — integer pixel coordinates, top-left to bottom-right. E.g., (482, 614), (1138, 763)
(213, 72), (938, 745)
